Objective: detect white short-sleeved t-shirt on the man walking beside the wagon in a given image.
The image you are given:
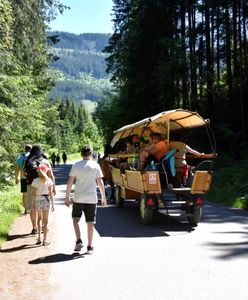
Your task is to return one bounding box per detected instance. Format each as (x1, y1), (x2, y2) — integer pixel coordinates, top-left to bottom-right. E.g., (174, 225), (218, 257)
(69, 160), (103, 204)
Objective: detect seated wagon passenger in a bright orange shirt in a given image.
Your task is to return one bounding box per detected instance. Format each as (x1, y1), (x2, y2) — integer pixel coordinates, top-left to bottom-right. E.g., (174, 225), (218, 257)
(139, 132), (168, 170)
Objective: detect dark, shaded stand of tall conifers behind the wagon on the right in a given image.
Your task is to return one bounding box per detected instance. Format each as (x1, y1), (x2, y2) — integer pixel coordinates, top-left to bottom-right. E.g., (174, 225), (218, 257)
(93, 0), (248, 208)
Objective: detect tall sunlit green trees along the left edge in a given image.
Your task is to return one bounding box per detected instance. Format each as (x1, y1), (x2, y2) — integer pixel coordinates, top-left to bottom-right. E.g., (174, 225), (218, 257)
(0, 0), (67, 188)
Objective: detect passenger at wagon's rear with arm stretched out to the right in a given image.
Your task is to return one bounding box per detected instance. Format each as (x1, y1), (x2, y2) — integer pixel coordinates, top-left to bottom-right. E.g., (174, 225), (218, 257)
(169, 135), (204, 186)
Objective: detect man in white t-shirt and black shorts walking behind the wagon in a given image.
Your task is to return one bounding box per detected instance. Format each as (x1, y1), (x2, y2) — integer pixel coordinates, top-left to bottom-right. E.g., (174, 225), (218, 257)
(65, 145), (107, 252)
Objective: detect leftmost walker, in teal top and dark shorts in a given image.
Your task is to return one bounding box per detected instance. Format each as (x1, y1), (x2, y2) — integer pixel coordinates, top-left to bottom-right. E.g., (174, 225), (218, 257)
(15, 144), (32, 214)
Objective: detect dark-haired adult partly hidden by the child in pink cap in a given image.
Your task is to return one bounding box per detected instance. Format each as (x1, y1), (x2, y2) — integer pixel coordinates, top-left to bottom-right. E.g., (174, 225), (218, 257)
(23, 144), (55, 234)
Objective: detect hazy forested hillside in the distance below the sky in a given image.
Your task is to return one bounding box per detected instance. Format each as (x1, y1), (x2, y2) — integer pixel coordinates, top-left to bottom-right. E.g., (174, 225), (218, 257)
(48, 31), (111, 103)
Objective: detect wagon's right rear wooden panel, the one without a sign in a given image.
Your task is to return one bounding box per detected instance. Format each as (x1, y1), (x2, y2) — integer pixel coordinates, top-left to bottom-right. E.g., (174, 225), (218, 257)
(190, 171), (212, 194)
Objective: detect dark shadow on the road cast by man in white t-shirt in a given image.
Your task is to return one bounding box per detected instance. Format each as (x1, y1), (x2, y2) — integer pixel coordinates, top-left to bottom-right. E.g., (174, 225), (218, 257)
(28, 252), (87, 265)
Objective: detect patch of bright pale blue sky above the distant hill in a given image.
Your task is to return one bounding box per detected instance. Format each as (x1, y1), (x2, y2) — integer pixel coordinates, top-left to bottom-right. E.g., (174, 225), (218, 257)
(49, 0), (113, 34)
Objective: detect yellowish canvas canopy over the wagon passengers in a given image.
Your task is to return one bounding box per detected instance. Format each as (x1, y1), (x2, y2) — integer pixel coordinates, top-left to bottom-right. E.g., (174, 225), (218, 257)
(111, 109), (209, 147)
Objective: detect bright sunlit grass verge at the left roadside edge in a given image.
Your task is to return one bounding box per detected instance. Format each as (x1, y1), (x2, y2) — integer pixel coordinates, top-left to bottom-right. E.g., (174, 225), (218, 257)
(0, 186), (23, 247)
